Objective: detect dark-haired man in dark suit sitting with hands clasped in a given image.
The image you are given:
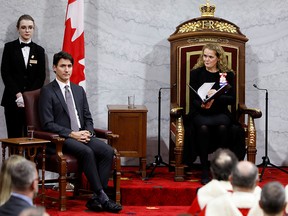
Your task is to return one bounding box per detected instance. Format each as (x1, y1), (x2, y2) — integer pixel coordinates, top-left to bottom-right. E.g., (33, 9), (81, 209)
(39, 51), (122, 212)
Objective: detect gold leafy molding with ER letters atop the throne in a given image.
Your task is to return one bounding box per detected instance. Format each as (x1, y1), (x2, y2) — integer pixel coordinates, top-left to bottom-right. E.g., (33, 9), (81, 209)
(178, 19), (238, 34)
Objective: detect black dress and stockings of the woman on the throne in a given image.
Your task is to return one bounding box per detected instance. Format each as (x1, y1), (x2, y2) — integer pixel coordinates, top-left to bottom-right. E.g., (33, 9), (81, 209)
(183, 67), (236, 170)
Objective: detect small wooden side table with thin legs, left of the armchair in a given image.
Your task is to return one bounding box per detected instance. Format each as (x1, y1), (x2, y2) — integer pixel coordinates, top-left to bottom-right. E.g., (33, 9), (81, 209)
(0, 137), (50, 204)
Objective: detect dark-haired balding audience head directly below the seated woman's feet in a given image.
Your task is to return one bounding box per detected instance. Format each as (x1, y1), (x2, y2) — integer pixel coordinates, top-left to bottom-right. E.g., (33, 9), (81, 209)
(210, 148), (238, 181)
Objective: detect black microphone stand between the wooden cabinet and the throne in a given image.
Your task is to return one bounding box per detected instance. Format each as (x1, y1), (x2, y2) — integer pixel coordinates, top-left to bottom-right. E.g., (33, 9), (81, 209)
(145, 84), (172, 180)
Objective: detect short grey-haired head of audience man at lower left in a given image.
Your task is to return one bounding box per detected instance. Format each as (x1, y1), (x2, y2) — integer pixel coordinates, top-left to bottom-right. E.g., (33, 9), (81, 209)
(9, 156), (38, 198)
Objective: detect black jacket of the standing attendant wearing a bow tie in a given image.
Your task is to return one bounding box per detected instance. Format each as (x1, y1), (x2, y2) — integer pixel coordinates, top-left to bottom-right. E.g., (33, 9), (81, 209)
(1, 39), (46, 107)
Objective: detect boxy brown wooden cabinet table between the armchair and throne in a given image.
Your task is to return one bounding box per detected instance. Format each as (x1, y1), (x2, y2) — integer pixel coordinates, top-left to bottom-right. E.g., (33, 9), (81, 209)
(107, 105), (148, 178)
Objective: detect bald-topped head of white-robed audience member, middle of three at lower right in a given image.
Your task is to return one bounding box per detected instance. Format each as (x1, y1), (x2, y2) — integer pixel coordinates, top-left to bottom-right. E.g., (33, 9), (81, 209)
(230, 161), (258, 192)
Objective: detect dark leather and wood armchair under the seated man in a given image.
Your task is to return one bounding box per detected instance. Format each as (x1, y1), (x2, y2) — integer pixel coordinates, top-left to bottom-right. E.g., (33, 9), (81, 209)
(23, 89), (121, 211)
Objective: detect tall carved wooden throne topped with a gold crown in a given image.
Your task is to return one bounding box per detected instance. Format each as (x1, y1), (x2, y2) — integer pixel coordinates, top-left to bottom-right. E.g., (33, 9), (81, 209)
(168, 1), (262, 181)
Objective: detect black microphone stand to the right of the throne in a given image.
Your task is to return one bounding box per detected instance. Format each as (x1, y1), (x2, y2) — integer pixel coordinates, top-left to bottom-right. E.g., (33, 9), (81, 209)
(253, 84), (288, 182)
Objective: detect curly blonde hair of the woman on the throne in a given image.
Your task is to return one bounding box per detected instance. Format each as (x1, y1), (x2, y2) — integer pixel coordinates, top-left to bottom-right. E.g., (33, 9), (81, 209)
(193, 43), (232, 73)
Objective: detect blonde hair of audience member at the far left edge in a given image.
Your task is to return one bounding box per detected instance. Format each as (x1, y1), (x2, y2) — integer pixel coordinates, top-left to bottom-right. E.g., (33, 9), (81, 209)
(0, 155), (26, 205)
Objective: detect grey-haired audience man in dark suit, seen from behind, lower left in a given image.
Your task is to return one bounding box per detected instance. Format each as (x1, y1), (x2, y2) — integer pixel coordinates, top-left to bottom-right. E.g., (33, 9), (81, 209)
(0, 158), (38, 216)
